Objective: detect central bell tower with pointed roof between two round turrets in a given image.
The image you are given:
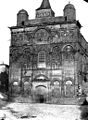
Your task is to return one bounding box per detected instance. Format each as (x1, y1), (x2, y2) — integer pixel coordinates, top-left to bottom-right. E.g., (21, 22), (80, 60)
(36, 0), (55, 18)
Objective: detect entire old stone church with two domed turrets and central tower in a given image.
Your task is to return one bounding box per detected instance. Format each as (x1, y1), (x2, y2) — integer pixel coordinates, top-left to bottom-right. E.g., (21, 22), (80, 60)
(9, 0), (88, 103)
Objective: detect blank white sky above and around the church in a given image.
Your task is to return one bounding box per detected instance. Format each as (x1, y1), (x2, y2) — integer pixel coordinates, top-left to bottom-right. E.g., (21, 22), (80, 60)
(0, 0), (88, 64)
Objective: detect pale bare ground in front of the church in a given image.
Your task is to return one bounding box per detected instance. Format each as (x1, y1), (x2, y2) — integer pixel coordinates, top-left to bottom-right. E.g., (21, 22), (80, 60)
(0, 103), (81, 120)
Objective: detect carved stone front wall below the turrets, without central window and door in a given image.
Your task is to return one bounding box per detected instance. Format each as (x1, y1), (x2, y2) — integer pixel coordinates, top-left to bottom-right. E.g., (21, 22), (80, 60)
(10, 11), (86, 100)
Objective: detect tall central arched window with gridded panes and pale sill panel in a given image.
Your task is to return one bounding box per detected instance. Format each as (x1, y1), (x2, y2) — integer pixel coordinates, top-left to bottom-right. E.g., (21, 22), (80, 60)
(38, 51), (46, 68)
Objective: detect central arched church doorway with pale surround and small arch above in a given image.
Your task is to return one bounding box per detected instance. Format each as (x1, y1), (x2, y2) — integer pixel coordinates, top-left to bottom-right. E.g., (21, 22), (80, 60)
(32, 74), (50, 103)
